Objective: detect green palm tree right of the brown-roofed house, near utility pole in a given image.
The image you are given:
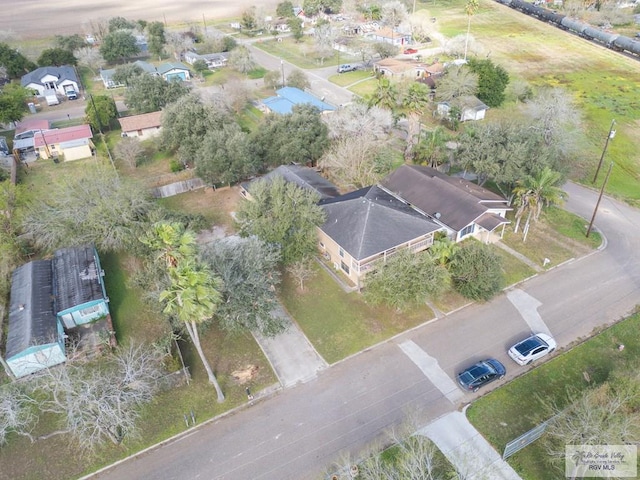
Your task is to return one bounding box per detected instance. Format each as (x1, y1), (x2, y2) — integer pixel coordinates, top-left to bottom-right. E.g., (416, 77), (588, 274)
(513, 167), (565, 242)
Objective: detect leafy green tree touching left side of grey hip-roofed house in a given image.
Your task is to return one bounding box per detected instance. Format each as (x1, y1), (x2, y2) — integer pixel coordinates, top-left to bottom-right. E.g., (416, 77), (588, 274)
(237, 176), (325, 265)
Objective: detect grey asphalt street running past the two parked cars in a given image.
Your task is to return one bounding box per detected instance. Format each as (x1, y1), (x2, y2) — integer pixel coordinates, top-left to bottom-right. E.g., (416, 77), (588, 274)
(91, 184), (640, 480)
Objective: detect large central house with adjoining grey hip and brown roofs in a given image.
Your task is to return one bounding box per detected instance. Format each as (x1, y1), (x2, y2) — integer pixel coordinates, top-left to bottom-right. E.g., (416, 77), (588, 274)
(318, 165), (510, 286)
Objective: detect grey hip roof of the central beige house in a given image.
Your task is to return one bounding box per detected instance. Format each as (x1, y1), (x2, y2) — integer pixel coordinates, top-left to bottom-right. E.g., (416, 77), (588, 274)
(320, 186), (440, 260)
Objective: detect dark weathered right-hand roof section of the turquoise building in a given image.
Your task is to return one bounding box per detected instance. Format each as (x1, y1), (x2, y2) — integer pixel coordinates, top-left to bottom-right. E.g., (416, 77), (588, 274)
(52, 245), (104, 313)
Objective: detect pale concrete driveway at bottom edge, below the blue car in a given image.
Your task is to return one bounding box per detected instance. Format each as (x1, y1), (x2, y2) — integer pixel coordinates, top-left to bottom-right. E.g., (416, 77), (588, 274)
(416, 412), (521, 480)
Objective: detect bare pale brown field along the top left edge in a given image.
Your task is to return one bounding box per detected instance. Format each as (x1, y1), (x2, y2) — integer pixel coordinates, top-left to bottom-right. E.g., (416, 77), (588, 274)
(0, 0), (278, 38)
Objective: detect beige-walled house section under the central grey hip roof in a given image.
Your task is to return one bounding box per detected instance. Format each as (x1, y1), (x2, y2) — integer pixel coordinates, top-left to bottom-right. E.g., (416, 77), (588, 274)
(318, 185), (444, 286)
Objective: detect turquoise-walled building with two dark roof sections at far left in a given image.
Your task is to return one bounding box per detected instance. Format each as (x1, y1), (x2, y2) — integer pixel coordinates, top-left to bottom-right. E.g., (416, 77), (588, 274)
(5, 245), (109, 378)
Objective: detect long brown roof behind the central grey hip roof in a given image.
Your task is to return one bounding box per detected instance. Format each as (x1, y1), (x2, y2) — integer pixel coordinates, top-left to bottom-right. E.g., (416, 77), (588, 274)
(380, 165), (507, 231)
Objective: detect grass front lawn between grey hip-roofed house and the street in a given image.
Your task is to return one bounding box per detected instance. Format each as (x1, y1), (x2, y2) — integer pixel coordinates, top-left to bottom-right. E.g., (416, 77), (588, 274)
(280, 265), (434, 363)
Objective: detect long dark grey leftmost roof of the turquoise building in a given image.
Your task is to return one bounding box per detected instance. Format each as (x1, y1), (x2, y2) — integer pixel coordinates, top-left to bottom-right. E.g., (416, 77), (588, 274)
(5, 260), (58, 359)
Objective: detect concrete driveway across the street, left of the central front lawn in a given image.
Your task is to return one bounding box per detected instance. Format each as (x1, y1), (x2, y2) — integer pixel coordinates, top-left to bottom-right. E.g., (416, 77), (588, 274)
(253, 305), (328, 388)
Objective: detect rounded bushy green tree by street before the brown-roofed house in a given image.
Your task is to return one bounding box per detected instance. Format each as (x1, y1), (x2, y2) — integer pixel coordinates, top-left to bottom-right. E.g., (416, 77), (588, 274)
(449, 240), (503, 301)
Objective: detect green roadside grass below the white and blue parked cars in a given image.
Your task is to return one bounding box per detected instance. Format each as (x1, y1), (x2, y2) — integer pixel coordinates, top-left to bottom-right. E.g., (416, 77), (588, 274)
(467, 314), (640, 480)
